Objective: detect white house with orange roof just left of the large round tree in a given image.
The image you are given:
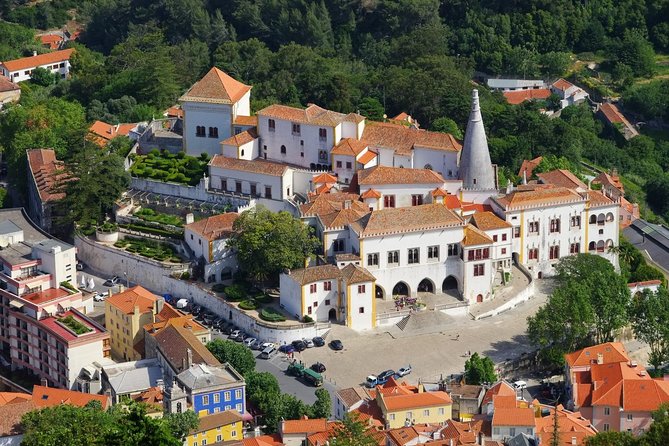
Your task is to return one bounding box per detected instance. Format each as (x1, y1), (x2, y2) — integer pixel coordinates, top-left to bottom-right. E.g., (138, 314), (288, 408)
(184, 212), (239, 282)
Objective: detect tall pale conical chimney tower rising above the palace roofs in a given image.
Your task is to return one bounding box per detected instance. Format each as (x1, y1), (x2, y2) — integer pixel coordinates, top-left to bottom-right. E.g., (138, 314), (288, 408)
(460, 89), (497, 191)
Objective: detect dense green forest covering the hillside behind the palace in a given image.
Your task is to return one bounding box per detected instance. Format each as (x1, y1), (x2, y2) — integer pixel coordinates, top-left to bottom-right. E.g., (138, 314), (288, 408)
(0, 0), (669, 218)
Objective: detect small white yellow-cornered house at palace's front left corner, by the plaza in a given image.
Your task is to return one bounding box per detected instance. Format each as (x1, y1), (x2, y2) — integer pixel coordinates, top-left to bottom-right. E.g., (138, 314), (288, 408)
(280, 264), (376, 330)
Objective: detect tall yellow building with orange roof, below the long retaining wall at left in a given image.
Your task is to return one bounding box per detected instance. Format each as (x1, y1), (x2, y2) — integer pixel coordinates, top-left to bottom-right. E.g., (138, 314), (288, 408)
(105, 286), (163, 361)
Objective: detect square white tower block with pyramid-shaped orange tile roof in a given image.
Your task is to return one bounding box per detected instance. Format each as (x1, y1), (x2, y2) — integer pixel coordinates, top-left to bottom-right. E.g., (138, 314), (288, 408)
(179, 67), (251, 156)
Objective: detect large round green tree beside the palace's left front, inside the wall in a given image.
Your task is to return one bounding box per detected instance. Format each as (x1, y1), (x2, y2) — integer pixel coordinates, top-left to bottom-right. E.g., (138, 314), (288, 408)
(228, 206), (320, 282)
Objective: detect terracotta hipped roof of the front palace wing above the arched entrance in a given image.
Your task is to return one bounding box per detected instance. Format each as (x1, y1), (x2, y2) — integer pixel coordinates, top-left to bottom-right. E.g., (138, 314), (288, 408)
(352, 204), (463, 238)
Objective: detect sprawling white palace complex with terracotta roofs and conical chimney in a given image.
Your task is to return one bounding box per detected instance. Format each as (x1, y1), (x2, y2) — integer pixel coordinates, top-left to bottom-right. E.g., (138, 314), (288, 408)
(181, 68), (620, 330)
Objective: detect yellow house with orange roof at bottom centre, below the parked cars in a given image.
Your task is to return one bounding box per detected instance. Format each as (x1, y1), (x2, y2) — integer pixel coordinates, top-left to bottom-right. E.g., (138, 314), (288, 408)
(376, 378), (453, 429)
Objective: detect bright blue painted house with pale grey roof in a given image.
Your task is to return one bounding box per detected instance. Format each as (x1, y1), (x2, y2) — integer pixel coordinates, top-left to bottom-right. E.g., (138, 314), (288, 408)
(177, 364), (246, 416)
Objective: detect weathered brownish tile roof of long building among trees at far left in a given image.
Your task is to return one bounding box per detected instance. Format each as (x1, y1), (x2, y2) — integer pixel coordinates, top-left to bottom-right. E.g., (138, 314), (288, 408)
(27, 149), (68, 203)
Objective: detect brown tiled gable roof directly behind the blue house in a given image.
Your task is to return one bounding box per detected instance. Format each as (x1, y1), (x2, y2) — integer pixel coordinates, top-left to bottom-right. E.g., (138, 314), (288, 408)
(152, 325), (221, 372)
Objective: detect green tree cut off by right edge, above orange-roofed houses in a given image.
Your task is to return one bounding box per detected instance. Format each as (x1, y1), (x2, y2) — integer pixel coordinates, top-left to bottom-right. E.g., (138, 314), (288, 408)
(630, 287), (669, 370)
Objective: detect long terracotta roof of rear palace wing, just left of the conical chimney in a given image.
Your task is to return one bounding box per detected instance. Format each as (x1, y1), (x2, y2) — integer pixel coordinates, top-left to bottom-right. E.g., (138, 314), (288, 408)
(361, 122), (462, 155)
